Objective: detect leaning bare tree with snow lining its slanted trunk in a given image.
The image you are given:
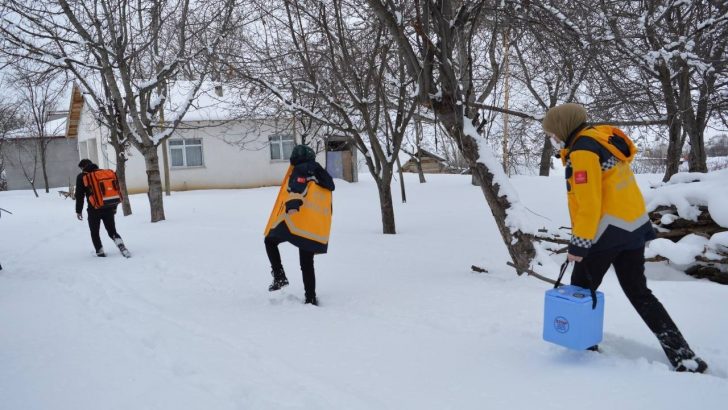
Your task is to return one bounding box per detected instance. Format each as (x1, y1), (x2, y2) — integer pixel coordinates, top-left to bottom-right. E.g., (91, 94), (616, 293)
(367, 0), (535, 274)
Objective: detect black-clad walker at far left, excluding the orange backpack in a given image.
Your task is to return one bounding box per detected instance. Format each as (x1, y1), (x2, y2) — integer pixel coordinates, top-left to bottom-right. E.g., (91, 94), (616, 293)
(75, 159), (131, 258)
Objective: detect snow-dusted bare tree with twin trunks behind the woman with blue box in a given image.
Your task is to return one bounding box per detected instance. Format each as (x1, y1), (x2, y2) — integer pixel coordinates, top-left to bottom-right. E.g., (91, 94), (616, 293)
(539, 0), (728, 180)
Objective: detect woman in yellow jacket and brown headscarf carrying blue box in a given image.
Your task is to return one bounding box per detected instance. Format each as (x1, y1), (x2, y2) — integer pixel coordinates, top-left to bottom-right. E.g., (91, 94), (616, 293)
(542, 104), (708, 373)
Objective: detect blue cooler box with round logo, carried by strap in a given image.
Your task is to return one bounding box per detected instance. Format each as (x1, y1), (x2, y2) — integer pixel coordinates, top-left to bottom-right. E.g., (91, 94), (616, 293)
(543, 285), (604, 350)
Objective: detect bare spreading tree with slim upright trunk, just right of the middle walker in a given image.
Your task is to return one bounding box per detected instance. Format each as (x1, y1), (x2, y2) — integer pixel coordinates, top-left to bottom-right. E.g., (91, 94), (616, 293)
(230, 0), (416, 234)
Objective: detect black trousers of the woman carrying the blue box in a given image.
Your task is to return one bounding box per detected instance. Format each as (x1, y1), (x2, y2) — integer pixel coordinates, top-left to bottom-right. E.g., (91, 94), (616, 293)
(571, 246), (695, 366)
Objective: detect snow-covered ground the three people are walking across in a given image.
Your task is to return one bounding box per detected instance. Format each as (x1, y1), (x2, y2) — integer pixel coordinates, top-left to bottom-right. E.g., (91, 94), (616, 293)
(0, 171), (728, 410)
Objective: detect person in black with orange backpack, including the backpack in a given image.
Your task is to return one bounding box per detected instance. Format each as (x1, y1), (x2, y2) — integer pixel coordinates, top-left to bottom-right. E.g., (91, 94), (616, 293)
(75, 159), (131, 258)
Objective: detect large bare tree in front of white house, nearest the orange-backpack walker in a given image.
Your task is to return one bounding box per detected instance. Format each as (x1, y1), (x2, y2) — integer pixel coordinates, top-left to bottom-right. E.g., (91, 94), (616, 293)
(0, 0), (235, 222)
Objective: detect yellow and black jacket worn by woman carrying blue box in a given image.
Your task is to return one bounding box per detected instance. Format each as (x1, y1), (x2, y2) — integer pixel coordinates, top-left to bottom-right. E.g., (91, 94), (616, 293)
(561, 125), (655, 256)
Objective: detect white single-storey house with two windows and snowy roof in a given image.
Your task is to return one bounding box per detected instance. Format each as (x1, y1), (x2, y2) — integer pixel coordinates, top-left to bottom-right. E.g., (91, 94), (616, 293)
(68, 82), (326, 193)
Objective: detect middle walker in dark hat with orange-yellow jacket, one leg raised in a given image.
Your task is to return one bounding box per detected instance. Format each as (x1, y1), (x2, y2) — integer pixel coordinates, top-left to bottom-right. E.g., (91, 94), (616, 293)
(265, 145), (335, 305)
